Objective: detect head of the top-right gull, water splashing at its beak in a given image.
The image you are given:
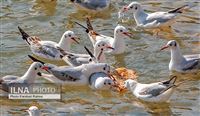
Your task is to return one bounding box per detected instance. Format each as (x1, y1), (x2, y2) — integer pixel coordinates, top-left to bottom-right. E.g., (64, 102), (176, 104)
(122, 2), (142, 13)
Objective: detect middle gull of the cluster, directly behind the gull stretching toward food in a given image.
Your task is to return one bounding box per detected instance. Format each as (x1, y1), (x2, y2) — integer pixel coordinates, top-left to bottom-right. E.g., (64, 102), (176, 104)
(60, 41), (114, 66)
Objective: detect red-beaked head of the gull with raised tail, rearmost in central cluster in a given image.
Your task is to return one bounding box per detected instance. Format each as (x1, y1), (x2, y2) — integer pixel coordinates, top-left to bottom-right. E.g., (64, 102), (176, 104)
(114, 25), (132, 38)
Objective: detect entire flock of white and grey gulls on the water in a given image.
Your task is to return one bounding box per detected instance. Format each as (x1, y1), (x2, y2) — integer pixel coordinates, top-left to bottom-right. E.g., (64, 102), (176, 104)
(0, 0), (200, 116)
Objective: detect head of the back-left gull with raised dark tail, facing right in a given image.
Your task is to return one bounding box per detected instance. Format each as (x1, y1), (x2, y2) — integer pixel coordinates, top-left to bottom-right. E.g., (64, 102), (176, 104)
(63, 31), (80, 44)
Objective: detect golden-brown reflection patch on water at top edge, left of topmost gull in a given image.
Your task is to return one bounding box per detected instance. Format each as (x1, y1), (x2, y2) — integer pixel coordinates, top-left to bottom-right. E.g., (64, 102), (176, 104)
(32, 0), (57, 16)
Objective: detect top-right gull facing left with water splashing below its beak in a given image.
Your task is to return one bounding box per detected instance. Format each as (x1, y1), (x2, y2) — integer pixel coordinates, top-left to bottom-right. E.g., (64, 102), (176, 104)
(121, 2), (188, 28)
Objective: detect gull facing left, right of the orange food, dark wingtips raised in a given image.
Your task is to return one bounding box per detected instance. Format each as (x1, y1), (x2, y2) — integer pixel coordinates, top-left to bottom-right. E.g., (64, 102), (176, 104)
(124, 76), (177, 102)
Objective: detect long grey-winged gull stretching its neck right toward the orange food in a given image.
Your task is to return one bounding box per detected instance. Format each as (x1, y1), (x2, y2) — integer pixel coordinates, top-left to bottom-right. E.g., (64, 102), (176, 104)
(29, 55), (111, 86)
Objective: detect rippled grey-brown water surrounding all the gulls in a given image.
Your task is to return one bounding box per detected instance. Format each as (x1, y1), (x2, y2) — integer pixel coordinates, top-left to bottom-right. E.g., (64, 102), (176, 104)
(0, 0), (200, 116)
